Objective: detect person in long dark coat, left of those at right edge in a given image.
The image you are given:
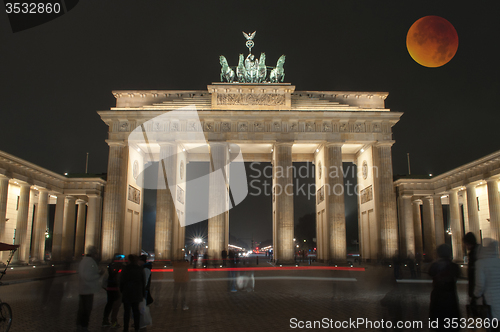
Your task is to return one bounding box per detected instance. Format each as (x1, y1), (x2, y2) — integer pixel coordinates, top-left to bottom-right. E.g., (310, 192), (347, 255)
(429, 244), (460, 331)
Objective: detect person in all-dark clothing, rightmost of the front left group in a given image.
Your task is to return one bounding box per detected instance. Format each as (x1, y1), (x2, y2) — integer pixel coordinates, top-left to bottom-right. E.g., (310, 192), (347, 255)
(120, 255), (146, 332)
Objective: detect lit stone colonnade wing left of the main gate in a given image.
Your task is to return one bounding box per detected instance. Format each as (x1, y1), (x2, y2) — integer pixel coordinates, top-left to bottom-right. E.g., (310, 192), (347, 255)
(0, 151), (106, 264)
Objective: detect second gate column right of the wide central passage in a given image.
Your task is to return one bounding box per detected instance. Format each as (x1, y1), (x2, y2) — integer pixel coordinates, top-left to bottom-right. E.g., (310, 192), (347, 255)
(322, 143), (347, 262)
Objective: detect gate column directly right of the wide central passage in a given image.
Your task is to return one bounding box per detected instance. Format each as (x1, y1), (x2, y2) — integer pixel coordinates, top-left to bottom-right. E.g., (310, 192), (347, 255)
(273, 142), (295, 263)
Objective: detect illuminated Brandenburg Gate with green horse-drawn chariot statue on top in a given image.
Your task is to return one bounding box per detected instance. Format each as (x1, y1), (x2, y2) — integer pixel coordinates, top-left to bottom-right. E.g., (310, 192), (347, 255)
(98, 34), (402, 262)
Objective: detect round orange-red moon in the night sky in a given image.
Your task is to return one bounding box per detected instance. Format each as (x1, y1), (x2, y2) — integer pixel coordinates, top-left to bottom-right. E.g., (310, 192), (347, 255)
(406, 16), (458, 68)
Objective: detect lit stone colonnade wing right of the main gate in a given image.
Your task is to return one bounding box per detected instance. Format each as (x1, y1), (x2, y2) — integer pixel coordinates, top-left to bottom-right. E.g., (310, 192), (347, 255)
(394, 151), (500, 261)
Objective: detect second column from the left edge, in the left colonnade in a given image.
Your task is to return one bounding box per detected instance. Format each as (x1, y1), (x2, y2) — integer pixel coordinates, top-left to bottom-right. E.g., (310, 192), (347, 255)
(12, 184), (30, 264)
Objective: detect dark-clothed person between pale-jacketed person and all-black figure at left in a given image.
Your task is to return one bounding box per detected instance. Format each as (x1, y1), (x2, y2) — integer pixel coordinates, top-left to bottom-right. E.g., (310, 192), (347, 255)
(102, 254), (125, 328)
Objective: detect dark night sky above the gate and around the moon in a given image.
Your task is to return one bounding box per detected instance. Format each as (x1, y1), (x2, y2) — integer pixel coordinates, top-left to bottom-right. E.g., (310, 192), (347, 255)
(0, 0), (500, 246)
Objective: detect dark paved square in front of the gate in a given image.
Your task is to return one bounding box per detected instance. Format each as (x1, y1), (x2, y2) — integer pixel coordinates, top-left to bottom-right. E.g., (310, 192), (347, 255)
(0, 262), (466, 332)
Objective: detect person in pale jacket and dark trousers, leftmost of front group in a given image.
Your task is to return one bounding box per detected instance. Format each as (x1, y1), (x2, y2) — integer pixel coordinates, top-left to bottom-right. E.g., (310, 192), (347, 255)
(76, 246), (104, 332)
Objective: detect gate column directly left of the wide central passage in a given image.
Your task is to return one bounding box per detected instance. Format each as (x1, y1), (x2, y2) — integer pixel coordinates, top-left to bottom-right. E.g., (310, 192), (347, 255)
(208, 142), (229, 260)
